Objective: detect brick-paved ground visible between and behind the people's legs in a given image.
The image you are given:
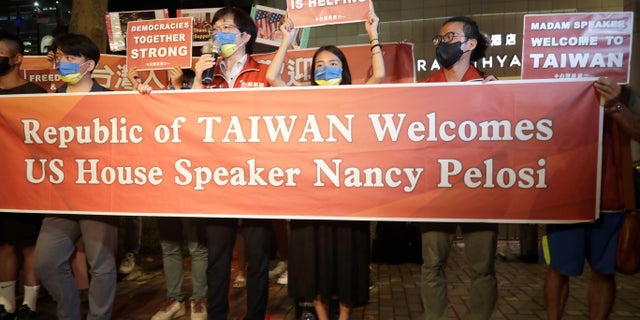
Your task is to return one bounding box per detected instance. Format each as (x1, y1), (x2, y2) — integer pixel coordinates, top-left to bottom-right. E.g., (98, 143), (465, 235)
(33, 241), (640, 320)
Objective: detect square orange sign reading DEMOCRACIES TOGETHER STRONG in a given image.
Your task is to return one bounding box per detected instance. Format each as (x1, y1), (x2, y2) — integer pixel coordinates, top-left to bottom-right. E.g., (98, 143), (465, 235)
(127, 17), (193, 70)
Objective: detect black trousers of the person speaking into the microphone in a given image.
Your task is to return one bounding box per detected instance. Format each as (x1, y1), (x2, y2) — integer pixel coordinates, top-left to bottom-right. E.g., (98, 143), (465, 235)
(205, 219), (272, 320)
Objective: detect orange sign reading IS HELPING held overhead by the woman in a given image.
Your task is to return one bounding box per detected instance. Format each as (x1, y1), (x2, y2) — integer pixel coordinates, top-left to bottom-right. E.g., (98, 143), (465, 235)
(287, 0), (371, 28)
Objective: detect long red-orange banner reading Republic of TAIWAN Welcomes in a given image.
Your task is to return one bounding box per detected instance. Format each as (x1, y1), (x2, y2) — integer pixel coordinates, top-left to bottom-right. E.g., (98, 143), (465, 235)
(0, 80), (602, 222)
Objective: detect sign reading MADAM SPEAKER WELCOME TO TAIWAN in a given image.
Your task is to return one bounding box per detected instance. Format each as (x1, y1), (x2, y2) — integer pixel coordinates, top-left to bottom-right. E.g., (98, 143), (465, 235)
(522, 12), (633, 84)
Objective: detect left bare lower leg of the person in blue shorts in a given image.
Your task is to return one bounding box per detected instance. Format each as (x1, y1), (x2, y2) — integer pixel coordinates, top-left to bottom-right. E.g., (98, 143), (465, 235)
(544, 266), (569, 320)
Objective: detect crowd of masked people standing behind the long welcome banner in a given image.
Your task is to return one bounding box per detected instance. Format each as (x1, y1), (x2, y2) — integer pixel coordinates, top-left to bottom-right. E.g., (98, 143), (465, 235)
(0, 3), (640, 320)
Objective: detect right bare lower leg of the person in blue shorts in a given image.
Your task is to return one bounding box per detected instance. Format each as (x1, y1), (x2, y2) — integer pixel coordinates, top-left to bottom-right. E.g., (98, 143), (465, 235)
(589, 270), (616, 320)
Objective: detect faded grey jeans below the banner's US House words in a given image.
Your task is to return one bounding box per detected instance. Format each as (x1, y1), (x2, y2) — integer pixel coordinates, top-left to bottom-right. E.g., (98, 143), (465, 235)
(34, 216), (118, 320)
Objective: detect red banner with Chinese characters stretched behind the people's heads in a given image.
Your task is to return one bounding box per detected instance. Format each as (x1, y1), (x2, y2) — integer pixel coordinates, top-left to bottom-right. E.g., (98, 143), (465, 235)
(22, 43), (415, 92)
